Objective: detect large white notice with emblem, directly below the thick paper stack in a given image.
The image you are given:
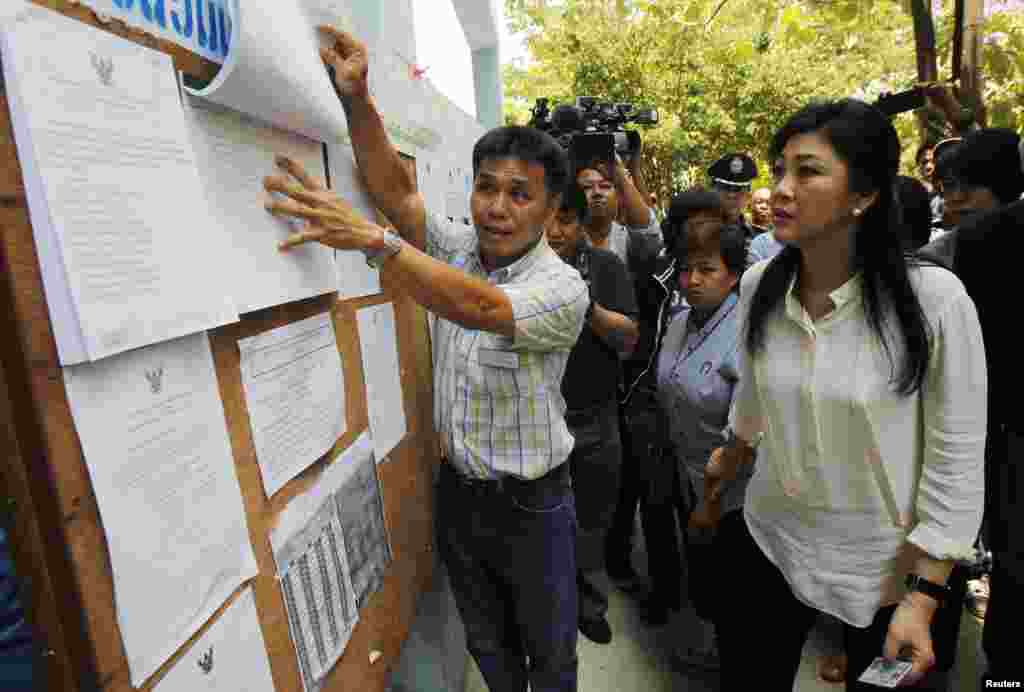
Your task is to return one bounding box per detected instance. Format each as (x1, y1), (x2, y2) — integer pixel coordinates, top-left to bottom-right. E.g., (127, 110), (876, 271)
(63, 333), (256, 687)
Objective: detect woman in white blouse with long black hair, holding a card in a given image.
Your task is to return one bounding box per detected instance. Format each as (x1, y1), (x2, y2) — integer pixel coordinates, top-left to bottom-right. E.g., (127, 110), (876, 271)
(691, 99), (987, 692)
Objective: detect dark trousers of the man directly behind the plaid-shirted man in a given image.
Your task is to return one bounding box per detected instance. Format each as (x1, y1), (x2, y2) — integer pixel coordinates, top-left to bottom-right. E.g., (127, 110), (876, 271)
(565, 400), (623, 619)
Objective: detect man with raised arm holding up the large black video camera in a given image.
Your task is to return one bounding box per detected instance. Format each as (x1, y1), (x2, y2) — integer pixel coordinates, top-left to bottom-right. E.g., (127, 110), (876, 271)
(577, 153), (662, 277)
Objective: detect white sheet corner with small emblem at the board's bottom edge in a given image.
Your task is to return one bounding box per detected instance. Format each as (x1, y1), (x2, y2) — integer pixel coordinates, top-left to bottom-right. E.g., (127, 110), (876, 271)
(154, 587), (273, 692)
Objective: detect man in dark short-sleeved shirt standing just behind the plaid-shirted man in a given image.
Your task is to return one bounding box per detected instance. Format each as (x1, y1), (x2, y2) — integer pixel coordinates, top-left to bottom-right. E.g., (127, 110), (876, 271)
(547, 189), (639, 644)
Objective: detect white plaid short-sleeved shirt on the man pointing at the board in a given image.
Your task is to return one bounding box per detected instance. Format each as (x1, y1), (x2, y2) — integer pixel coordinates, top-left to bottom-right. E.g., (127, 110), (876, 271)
(426, 214), (590, 479)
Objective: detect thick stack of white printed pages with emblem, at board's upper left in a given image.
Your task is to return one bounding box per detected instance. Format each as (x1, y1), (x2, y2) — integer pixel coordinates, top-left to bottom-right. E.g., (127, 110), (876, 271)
(2, 5), (238, 365)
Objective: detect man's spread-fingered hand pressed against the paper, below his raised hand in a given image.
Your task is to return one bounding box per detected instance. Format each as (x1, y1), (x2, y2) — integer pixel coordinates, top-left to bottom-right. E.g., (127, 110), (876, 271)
(263, 156), (383, 250)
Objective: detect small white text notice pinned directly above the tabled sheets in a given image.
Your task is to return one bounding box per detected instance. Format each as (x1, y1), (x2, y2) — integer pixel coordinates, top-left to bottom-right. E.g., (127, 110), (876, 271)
(239, 313), (345, 498)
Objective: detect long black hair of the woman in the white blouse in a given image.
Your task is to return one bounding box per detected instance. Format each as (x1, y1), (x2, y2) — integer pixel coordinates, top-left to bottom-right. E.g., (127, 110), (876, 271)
(746, 98), (931, 395)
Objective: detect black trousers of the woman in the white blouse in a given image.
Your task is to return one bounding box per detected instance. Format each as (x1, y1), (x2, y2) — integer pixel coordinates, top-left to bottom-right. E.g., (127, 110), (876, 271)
(715, 512), (954, 692)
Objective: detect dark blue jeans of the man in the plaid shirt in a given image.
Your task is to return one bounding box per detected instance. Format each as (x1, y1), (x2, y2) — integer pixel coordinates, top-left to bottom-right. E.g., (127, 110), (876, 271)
(435, 463), (577, 692)
